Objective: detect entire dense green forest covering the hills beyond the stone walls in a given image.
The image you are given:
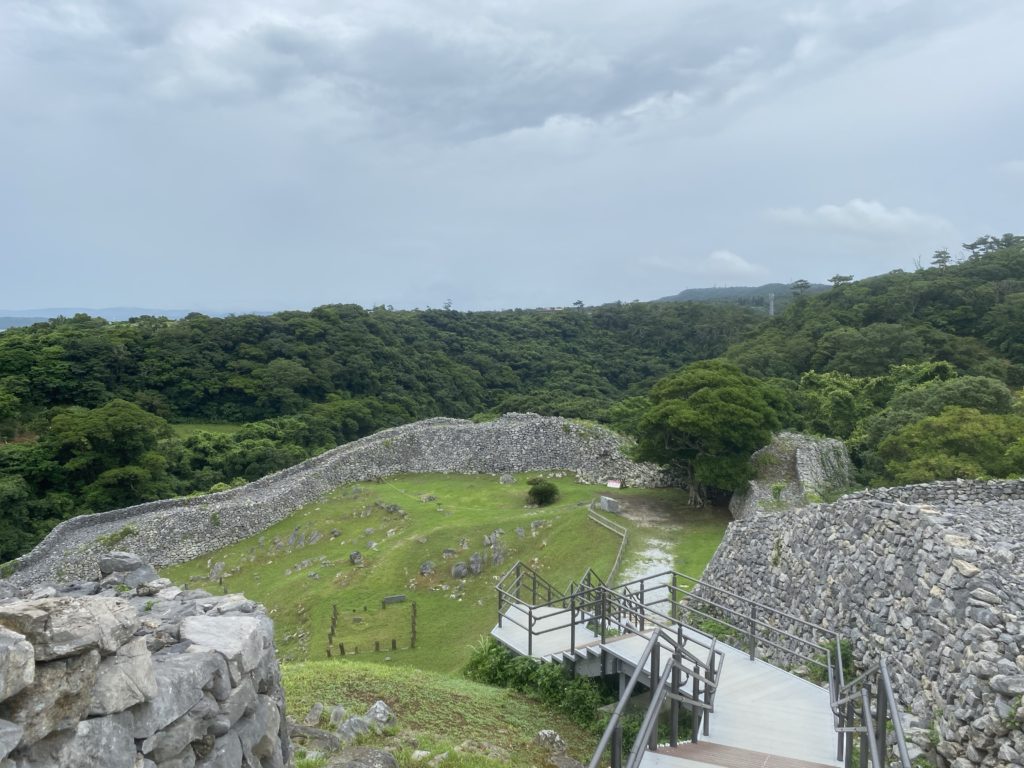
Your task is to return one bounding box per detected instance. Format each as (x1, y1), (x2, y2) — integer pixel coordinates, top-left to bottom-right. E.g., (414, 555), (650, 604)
(0, 234), (1024, 560)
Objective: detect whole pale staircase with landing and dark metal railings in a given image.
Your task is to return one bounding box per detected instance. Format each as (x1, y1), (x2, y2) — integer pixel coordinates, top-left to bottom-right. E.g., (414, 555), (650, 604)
(490, 563), (909, 768)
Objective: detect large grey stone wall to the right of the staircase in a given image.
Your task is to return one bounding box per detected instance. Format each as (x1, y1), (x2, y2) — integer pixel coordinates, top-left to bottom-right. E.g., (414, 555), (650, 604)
(705, 480), (1024, 768)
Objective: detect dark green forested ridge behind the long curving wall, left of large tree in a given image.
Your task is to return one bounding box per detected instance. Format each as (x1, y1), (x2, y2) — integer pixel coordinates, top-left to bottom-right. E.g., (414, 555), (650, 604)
(0, 303), (761, 560)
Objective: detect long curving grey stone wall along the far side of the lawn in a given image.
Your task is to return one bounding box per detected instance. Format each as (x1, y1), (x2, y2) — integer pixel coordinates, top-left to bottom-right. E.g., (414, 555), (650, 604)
(0, 414), (673, 596)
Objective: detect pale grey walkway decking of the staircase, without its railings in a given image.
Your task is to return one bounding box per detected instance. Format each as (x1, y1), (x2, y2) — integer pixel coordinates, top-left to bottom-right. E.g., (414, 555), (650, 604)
(490, 605), (842, 768)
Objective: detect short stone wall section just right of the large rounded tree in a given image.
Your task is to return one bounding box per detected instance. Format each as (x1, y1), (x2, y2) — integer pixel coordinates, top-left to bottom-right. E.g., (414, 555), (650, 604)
(729, 432), (853, 520)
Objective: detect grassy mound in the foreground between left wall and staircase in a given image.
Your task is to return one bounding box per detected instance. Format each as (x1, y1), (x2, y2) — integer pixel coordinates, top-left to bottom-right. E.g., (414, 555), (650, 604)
(284, 660), (598, 768)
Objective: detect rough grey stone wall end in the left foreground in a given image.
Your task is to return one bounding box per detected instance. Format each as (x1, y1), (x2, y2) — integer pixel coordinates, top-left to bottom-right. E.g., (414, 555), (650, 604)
(0, 552), (290, 768)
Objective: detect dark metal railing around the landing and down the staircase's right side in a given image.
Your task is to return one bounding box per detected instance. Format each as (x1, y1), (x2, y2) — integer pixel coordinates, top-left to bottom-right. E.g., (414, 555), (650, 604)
(498, 562), (910, 768)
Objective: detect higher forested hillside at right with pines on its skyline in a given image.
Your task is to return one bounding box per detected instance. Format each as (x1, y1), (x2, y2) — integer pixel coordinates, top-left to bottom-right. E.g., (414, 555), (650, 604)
(727, 236), (1024, 384)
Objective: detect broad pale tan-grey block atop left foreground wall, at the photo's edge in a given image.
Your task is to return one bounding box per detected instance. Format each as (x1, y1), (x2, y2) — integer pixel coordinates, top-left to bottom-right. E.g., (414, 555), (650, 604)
(0, 597), (138, 662)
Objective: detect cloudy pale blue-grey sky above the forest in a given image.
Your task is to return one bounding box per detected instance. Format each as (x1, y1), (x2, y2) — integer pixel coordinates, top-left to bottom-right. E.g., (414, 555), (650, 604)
(0, 0), (1024, 311)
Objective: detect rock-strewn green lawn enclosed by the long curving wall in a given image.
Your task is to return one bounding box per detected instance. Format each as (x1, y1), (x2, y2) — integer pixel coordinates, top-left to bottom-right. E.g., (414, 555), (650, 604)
(163, 474), (724, 672)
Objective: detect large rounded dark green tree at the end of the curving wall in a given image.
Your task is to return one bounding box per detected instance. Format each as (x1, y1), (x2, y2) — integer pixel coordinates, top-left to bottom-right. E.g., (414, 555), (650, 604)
(637, 360), (788, 504)
